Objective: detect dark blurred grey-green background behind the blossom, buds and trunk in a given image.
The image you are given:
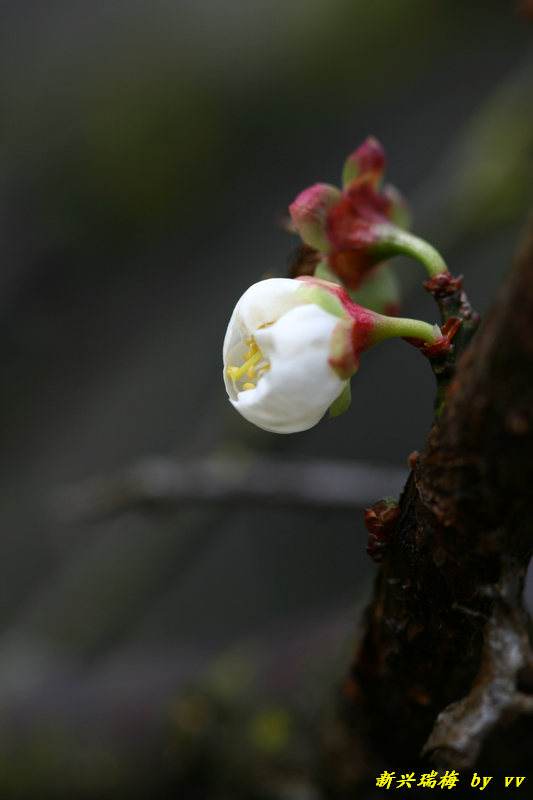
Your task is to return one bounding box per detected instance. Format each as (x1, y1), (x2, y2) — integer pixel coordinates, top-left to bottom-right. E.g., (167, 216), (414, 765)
(0, 0), (533, 800)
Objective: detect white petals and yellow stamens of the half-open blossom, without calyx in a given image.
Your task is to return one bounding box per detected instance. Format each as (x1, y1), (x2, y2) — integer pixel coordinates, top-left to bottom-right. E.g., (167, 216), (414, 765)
(223, 278), (347, 433)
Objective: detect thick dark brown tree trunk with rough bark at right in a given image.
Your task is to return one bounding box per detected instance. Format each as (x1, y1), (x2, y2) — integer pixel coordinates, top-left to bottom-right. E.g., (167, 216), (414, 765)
(334, 211), (533, 774)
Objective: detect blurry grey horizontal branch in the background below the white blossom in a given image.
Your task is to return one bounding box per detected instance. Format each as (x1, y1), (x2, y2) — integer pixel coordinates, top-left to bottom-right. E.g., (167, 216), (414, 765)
(50, 453), (409, 522)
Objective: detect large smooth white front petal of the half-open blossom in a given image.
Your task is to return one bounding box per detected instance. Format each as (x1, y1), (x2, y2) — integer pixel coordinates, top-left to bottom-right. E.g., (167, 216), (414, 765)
(230, 304), (346, 433)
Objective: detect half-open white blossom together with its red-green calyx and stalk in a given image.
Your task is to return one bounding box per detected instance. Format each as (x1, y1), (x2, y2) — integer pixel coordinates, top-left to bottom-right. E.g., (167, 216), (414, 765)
(223, 276), (442, 433)
